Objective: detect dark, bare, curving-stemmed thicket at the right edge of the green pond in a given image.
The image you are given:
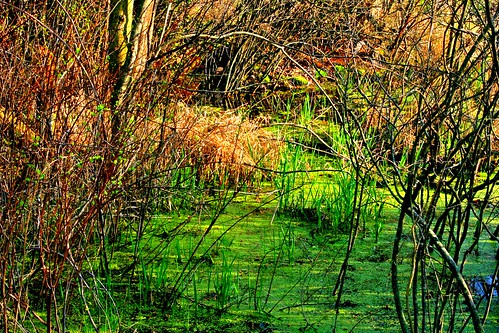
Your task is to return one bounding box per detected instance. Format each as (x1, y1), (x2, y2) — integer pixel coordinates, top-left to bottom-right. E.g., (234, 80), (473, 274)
(334, 1), (498, 332)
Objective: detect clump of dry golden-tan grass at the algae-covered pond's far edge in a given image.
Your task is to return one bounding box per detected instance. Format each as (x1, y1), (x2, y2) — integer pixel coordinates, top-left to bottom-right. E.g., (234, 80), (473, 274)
(164, 104), (282, 186)
